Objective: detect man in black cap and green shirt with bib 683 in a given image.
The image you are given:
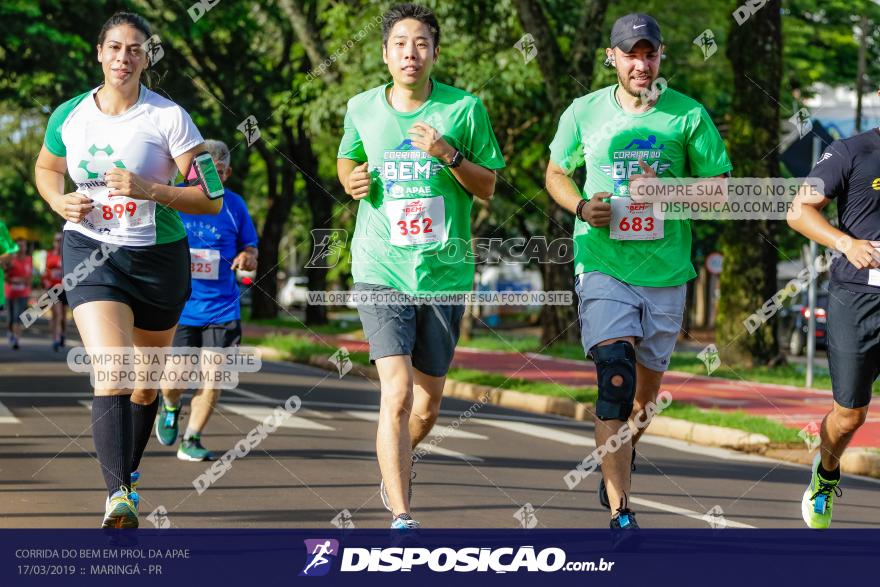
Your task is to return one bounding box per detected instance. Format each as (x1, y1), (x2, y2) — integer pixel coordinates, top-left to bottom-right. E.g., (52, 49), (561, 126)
(546, 14), (731, 528)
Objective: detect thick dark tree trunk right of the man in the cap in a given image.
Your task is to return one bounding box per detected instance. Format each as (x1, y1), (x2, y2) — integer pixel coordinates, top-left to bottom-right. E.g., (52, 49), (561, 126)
(715, 0), (782, 366)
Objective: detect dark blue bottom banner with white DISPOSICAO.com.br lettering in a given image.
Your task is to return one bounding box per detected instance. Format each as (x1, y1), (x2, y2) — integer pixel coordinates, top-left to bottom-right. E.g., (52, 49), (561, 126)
(0, 528), (880, 587)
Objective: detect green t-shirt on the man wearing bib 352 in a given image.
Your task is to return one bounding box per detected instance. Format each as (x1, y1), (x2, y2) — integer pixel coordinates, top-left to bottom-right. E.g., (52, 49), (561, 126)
(337, 81), (504, 293)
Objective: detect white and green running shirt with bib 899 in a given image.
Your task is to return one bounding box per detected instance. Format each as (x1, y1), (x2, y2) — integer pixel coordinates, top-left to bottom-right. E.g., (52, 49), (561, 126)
(44, 86), (204, 247)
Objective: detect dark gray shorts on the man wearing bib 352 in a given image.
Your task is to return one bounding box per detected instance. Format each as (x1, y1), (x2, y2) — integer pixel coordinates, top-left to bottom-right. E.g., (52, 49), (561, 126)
(354, 283), (464, 377)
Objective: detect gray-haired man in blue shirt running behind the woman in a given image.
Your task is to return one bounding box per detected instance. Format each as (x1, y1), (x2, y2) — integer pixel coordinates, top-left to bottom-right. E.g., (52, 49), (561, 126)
(156, 140), (257, 461)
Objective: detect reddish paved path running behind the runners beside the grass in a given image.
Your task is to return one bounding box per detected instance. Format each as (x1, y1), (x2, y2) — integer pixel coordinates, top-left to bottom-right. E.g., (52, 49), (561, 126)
(243, 324), (880, 448)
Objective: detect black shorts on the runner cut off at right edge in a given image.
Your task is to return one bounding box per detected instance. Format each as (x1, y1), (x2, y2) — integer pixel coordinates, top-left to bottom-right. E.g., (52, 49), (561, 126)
(828, 282), (880, 408)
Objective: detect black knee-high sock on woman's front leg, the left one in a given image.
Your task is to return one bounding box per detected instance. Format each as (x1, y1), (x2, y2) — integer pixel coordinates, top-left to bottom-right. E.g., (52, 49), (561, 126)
(92, 395), (131, 495)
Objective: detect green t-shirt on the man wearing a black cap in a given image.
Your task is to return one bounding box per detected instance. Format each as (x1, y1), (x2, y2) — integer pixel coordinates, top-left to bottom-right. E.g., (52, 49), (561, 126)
(550, 85), (732, 287)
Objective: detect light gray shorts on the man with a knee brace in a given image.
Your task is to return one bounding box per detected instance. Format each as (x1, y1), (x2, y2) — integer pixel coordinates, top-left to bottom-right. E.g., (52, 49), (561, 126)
(575, 271), (687, 371)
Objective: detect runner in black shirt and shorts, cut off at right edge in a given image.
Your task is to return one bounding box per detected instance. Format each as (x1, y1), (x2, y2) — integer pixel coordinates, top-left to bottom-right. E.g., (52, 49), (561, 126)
(788, 129), (880, 528)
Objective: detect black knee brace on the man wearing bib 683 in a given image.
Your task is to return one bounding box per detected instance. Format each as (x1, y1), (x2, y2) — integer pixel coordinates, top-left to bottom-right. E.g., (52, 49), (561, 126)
(590, 340), (636, 422)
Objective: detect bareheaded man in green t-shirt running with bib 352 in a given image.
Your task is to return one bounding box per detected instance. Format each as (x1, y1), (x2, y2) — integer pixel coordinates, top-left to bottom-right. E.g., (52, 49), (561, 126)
(337, 4), (504, 530)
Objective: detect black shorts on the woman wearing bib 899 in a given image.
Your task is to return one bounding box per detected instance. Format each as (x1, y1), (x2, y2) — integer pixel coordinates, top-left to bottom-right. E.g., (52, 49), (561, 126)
(61, 230), (190, 331)
